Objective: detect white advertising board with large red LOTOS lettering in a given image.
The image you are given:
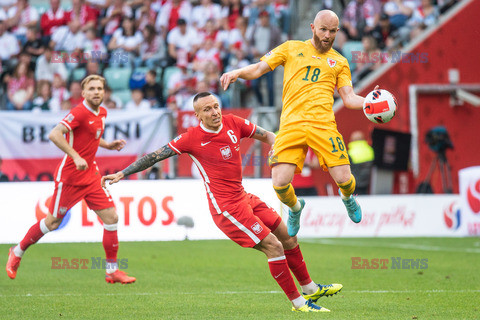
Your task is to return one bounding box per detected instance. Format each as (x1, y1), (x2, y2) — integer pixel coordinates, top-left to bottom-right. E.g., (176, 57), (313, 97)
(0, 179), (279, 243)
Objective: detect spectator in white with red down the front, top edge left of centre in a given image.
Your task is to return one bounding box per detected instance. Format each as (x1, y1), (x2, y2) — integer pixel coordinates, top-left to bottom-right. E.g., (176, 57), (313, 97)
(155, 0), (192, 39)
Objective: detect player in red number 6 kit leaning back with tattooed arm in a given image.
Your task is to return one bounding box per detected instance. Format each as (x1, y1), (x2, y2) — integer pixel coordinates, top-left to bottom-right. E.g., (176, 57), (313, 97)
(102, 92), (343, 312)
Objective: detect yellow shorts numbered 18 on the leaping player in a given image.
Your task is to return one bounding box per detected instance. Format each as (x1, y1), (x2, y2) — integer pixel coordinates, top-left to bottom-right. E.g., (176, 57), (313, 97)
(269, 125), (350, 173)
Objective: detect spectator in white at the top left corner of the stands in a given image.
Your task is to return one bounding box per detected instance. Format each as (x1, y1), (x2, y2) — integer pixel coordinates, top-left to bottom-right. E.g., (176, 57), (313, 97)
(8, 0), (39, 45)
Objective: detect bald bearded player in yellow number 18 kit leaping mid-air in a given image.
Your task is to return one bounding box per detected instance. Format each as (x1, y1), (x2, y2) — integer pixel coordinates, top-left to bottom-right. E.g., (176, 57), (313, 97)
(220, 10), (374, 236)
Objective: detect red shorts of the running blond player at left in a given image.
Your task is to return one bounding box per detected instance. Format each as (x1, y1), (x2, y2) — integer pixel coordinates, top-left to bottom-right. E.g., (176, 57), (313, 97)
(49, 180), (115, 218)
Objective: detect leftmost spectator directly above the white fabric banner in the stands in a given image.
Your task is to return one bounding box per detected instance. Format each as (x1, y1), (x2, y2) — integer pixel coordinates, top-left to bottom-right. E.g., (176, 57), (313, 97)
(7, 63), (35, 110)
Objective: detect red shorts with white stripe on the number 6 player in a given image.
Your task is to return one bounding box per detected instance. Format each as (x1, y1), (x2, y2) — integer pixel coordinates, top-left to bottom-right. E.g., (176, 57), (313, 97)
(212, 193), (282, 248)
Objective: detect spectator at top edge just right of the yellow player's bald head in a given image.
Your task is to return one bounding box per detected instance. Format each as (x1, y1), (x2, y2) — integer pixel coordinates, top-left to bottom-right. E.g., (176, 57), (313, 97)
(337, 0), (380, 44)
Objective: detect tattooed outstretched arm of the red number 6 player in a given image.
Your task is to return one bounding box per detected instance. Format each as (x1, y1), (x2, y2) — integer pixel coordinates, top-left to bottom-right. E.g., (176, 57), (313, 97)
(102, 144), (176, 188)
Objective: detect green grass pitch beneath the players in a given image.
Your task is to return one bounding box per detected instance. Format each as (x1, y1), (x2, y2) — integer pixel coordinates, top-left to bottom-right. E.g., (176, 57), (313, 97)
(0, 238), (480, 320)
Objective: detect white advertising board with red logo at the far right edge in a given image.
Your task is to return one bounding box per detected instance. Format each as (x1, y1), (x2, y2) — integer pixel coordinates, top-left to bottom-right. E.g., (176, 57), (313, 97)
(458, 166), (480, 236)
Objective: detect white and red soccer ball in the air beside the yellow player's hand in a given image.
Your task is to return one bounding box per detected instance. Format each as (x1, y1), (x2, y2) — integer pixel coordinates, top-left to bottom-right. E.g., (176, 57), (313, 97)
(363, 90), (397, 123)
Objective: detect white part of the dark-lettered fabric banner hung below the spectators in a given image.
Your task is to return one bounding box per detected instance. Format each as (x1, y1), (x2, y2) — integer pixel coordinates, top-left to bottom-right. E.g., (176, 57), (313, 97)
(0, 110), (172, 160)
